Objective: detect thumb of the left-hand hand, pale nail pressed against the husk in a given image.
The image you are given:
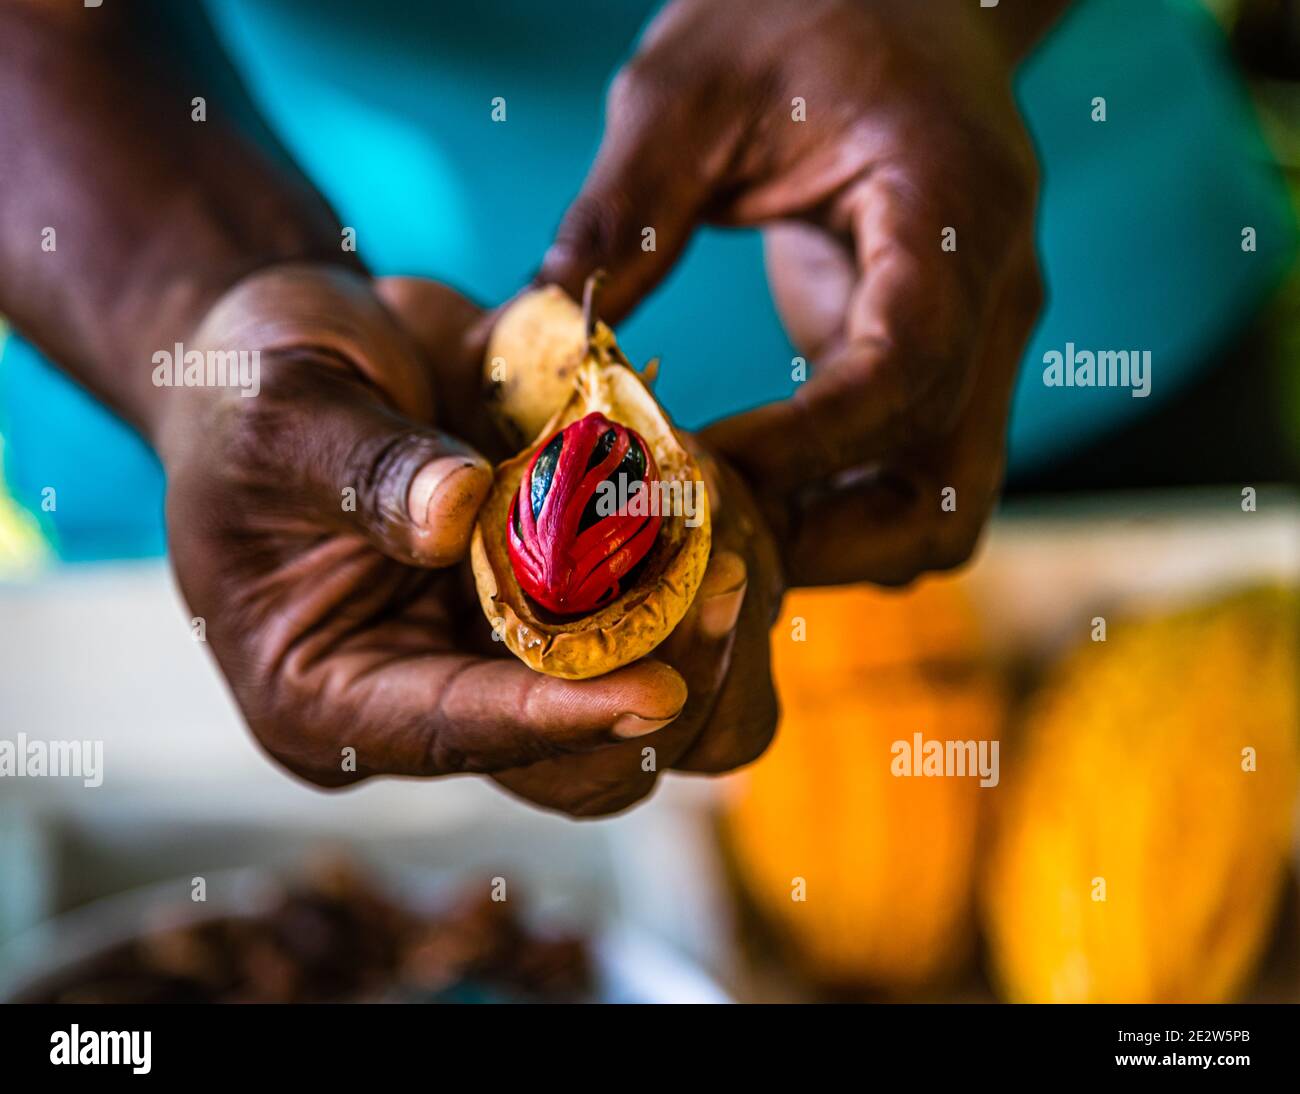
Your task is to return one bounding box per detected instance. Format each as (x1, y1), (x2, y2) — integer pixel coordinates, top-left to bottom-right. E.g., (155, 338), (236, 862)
(189, 266), (491, 566)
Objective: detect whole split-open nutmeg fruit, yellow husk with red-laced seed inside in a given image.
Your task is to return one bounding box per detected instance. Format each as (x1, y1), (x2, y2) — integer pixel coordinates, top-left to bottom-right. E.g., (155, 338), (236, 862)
(471, 279), (711, 680)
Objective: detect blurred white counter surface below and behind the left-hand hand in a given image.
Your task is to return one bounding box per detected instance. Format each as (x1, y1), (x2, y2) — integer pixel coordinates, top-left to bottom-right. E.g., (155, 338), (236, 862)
(0, 563), (728, 969)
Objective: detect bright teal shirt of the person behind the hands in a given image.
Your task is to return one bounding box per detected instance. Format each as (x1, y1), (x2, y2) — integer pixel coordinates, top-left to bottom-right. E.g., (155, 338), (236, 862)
(0, 0), (1296, 559)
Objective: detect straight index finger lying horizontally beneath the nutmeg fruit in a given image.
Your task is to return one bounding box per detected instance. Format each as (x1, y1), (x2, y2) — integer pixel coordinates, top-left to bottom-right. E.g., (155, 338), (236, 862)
(327, 655), (686, 776)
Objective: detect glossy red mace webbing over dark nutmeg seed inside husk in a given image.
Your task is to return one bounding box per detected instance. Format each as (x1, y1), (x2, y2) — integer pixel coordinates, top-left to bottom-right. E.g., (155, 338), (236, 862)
(508, 413), (660, 616)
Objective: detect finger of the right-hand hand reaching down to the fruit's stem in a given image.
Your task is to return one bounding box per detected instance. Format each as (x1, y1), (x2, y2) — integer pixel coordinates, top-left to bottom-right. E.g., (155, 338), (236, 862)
(538, 61), (723, 322)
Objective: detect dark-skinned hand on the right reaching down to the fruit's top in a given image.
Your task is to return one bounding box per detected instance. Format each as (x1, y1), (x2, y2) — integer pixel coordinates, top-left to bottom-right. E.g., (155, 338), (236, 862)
(541, 0), (1045, 585)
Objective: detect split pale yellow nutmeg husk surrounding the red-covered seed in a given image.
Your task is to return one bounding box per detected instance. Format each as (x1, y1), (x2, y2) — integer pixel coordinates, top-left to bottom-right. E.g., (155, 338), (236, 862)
(471, 285), (711, 680)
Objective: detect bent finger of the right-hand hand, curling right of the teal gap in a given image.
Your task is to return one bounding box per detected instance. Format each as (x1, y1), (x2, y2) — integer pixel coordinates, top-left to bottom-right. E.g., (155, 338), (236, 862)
(706, 169), (1021, 490)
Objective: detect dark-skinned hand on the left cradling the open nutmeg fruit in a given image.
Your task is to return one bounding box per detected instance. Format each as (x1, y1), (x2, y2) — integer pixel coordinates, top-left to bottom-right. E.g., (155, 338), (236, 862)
(159, 266), (779, 815)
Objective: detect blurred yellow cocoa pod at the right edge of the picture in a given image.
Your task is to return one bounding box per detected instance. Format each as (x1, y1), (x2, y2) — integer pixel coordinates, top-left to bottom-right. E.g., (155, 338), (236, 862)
(980, 590), (1300, 1003)
